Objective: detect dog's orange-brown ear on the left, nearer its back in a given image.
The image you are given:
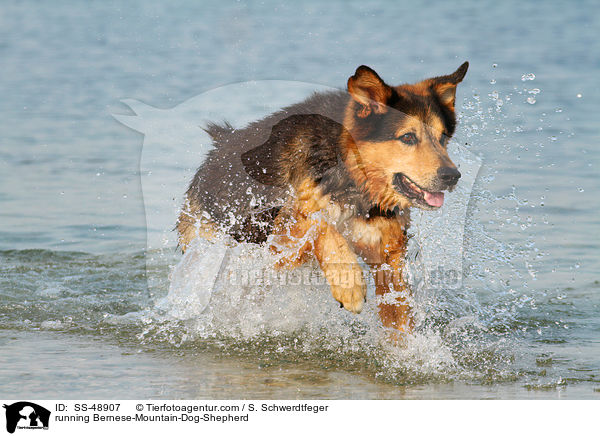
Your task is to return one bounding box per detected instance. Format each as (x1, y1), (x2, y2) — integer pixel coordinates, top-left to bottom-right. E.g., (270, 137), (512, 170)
(348, 65), (392, 118)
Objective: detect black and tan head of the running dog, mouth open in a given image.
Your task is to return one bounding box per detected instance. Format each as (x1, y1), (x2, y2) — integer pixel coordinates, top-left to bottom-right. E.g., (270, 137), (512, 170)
(344, 62), (469, 210)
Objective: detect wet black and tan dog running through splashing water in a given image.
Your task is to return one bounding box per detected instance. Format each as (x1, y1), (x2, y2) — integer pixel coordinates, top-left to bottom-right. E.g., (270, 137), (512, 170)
(177, 62), (468, 331)
